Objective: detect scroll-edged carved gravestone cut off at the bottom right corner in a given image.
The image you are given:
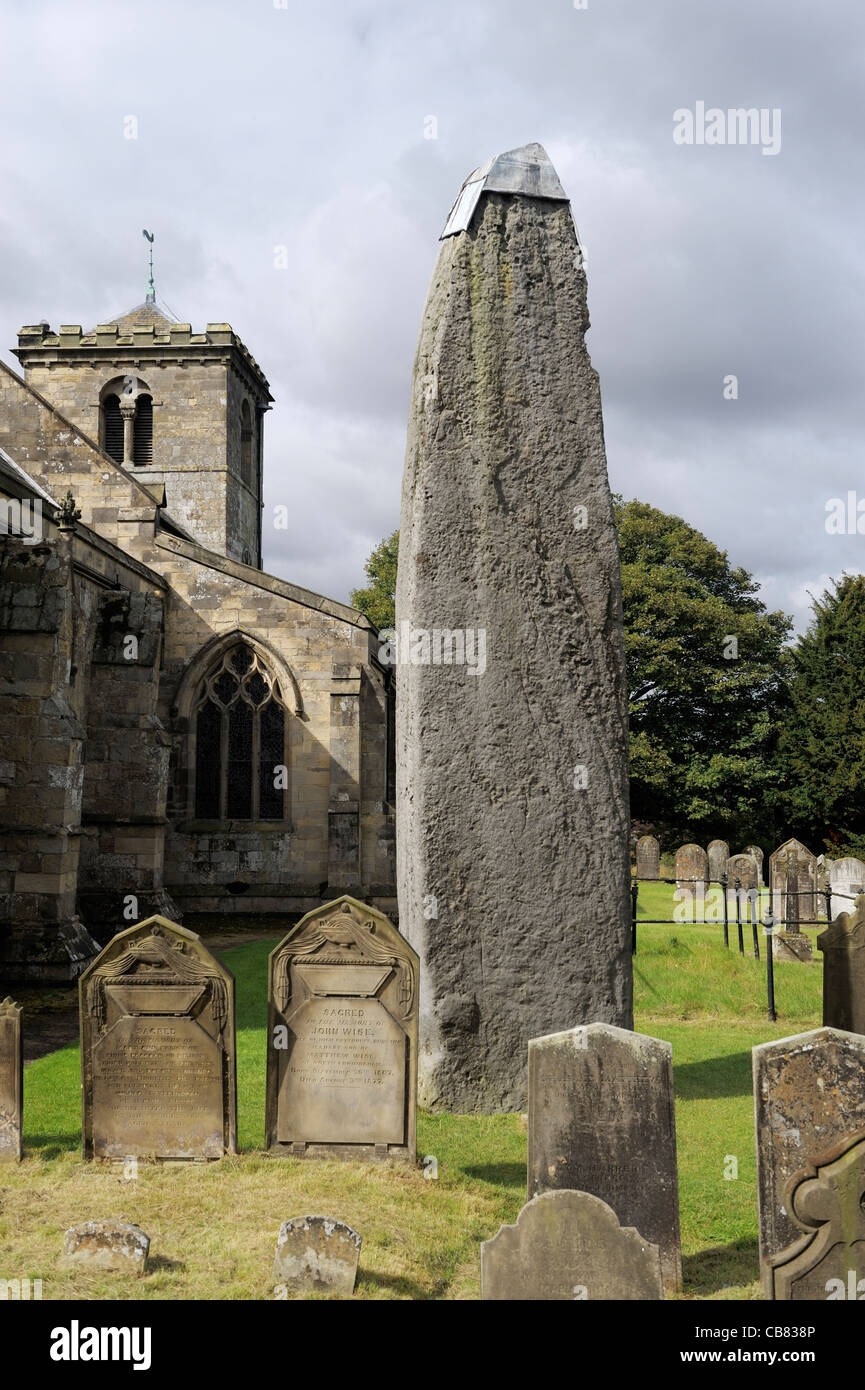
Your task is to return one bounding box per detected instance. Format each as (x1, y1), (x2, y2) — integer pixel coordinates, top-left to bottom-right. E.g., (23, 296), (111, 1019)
(766, 1138), (865, 1302)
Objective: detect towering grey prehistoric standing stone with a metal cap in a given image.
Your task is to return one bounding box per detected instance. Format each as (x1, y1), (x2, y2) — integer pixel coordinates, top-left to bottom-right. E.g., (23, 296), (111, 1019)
(392, 145), (633, 1111)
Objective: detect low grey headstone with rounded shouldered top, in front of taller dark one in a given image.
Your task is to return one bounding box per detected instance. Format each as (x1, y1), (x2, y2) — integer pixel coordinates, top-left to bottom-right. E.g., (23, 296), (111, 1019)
(481, 1190), (663, 1302)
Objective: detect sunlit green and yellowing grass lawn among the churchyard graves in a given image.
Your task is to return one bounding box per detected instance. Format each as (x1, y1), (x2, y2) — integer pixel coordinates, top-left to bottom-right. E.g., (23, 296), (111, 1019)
(0, 884), (822, 1300)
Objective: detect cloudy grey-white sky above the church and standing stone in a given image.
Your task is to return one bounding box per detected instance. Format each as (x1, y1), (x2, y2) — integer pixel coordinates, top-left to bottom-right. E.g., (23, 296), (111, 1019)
(0, 0), (865, 626)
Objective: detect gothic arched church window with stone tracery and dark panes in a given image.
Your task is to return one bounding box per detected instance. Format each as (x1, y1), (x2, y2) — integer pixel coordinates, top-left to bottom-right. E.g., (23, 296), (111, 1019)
(195, 642), (286, 820)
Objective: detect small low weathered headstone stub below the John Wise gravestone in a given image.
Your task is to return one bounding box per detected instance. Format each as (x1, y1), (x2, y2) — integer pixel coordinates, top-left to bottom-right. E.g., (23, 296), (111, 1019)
(273, 1216), (362, 1298)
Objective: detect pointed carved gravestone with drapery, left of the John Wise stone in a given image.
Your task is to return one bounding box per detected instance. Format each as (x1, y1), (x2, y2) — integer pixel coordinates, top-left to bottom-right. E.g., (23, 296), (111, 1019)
(79, 916), (238, 1161)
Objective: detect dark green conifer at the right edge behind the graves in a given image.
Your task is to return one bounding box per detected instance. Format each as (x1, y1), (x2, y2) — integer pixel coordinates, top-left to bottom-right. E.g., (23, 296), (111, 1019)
(780, 574), (865, 855)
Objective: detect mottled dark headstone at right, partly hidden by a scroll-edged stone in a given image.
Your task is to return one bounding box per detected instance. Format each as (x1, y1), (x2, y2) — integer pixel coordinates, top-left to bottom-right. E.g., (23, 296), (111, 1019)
(752, 1029), (865, 1297)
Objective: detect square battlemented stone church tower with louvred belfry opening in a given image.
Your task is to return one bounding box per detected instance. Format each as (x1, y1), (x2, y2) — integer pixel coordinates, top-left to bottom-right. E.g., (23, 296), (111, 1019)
(14, 292), (273, 569)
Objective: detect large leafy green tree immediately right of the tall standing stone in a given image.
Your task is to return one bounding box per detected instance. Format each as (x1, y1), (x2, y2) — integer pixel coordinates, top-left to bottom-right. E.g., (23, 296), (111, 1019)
(613, 496), (791, 841)
